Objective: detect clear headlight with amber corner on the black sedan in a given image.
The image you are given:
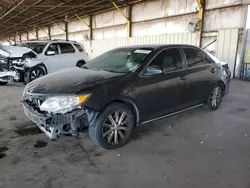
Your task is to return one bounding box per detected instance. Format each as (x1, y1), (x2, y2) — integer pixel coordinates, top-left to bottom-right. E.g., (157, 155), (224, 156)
(40, 94), (90, 113)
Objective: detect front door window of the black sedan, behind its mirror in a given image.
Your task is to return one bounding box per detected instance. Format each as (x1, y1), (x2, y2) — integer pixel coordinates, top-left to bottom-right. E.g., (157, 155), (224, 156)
(150, 48), (183, 72)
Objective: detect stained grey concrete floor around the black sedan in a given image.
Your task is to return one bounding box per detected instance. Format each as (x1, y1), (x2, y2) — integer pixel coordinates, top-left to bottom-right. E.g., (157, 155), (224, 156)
(0, 80), (250, 188)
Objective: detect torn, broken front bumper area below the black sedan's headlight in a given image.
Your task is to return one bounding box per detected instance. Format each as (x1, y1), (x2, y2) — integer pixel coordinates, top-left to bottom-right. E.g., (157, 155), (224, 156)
(23, 101), (98, 140)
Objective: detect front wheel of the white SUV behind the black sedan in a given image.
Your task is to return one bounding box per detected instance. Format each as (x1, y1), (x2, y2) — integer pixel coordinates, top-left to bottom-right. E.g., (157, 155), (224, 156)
(24, 66), (46, 85)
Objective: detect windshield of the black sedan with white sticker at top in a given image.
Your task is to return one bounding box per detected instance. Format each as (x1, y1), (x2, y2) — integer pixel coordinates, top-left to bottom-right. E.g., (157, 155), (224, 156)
(84, 48), (153, 73)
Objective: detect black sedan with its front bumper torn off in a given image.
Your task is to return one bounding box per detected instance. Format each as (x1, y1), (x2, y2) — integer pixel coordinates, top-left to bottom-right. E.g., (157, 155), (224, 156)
(23, 45), (230, 149)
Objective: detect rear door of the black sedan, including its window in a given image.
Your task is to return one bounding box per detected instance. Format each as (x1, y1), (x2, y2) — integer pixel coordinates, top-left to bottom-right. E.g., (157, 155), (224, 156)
(183, 47), (217, 107)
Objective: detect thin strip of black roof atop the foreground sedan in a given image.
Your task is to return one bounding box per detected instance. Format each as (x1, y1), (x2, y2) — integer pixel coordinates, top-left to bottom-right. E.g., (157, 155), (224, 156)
(116, 44), (199, 50)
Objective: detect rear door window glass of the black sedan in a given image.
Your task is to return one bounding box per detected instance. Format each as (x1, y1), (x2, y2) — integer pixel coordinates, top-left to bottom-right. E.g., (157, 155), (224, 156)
(183, 48), (209, 68)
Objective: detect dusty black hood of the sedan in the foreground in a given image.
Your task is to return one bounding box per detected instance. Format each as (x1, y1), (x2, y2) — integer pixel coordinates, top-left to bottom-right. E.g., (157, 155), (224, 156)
(25, 67), (124, 95)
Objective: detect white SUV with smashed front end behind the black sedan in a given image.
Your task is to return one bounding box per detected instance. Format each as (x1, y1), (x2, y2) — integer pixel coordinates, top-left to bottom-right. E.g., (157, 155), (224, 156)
(0, 40), (88, 85)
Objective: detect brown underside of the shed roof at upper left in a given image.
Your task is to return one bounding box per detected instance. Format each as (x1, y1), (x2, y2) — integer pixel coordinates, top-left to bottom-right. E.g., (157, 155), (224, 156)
(0, 0), (143, 38)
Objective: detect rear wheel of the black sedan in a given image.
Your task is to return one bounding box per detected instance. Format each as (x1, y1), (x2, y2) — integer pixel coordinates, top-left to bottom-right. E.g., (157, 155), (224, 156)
(207, 84), (223, 110)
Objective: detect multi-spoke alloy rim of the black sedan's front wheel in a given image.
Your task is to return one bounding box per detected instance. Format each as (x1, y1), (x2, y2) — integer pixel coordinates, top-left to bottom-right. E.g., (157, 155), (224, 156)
(102, 111), (130, 145)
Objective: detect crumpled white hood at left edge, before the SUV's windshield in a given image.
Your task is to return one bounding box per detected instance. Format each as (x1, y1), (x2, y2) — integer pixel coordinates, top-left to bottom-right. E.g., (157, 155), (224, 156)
(0, 45), (37, 57)
